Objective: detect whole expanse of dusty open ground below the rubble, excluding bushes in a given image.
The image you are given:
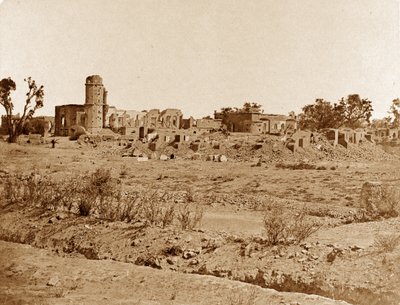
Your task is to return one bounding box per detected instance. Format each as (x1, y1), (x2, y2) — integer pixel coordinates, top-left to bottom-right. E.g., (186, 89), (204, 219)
(0, 139), (400, 305)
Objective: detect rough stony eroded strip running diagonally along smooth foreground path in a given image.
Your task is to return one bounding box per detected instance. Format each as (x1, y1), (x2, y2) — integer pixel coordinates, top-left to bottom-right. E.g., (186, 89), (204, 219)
(0, 208), (399, 305)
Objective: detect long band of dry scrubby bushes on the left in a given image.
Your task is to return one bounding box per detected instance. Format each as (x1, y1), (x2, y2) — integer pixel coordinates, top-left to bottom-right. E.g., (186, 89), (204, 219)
(2, 168), (203, 230)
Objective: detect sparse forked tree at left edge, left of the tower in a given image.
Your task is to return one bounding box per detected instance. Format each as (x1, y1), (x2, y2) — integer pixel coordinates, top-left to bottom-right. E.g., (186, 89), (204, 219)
(0, 77), (44, 143)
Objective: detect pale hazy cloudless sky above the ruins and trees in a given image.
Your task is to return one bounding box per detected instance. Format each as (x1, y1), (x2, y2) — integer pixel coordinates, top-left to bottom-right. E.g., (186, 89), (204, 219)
(0, 0), (400, 118)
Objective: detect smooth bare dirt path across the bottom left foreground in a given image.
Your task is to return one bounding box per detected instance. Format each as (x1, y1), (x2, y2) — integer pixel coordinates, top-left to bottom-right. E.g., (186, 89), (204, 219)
(0, 241), (346, 305)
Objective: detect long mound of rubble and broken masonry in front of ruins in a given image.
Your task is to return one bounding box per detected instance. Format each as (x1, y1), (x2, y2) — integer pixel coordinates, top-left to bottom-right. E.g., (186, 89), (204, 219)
(77, 127), (398, 164)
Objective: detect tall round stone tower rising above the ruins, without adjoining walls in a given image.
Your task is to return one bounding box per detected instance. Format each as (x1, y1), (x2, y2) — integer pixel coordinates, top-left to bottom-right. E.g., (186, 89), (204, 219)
(85, 75), (108, 133)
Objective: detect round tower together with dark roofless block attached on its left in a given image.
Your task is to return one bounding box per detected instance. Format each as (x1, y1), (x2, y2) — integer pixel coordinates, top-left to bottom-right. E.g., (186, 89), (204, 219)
(54, 75), (108, 136)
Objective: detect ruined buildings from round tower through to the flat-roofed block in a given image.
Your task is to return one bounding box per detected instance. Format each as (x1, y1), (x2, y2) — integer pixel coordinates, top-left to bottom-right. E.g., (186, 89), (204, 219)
(54, 75), (296, 138)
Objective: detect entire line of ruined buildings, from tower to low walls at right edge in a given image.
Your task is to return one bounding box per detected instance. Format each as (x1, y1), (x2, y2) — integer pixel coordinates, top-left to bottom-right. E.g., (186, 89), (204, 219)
(54, 75), (400, 151)
